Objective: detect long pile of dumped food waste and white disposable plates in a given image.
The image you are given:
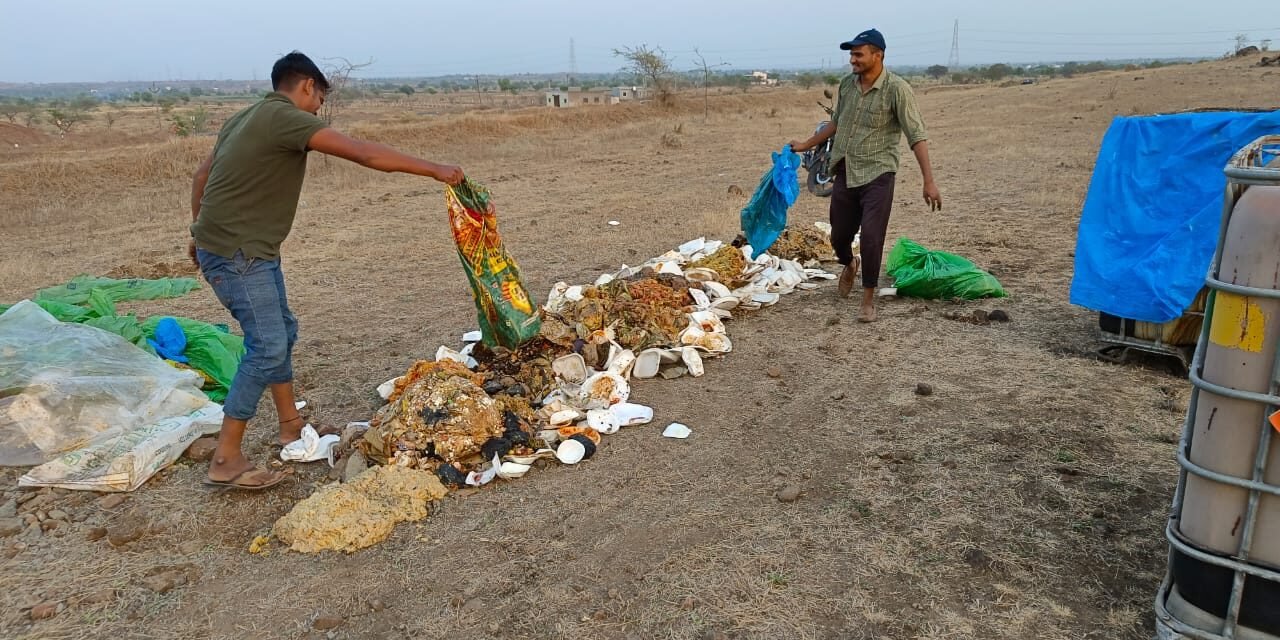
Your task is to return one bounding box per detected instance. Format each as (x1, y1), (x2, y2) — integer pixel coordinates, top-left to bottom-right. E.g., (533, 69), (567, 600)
(276, 224), (836, 550)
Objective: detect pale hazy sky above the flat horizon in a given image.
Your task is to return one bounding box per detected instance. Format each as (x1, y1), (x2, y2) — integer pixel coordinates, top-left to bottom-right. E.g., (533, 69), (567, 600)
(0, 0), (1280, 82)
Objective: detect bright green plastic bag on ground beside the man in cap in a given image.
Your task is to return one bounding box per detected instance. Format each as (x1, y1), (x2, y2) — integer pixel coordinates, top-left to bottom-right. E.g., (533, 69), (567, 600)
(886, 238), (1005, 300)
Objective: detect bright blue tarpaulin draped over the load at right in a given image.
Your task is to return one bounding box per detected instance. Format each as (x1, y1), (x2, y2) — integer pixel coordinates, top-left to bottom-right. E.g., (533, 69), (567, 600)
(1071, 111), (1280, 323)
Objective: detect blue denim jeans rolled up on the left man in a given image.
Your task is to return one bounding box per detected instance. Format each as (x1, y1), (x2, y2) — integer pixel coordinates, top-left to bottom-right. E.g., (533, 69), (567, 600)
(196, 250), (298, 420)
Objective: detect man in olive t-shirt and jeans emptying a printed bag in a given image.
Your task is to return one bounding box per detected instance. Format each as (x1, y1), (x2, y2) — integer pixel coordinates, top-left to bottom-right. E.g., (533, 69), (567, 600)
(189, 51), (462, 489)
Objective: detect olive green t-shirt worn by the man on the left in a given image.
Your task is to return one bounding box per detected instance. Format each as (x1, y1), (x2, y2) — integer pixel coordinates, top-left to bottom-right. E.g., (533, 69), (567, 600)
(191, 92), (325, 260)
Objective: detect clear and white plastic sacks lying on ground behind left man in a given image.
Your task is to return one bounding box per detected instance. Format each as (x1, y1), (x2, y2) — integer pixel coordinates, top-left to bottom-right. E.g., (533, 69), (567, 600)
(0, 301), (221, 490)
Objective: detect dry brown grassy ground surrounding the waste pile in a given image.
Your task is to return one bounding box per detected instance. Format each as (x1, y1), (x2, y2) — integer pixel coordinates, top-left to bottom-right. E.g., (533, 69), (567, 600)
(0, 55), (1277, 640)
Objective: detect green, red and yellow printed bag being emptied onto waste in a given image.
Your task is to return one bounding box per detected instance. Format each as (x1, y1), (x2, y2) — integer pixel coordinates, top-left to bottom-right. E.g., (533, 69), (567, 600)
(444, 180), (543, 349)
